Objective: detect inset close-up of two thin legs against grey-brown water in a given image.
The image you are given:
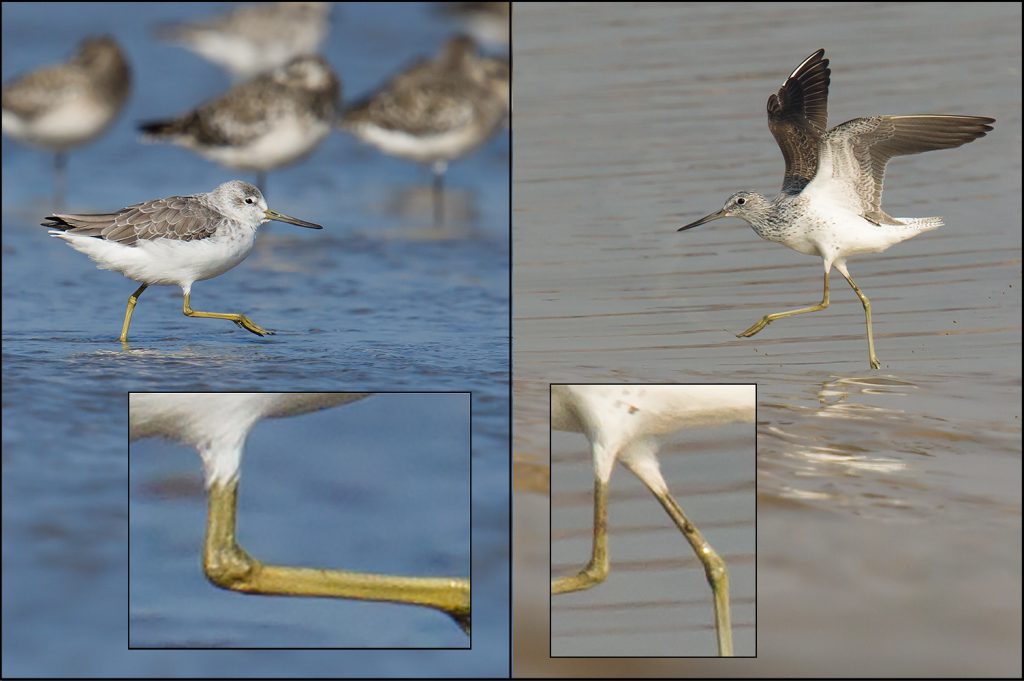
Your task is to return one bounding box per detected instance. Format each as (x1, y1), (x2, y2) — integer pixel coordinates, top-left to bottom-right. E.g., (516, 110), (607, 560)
(551, 384), (757, 657)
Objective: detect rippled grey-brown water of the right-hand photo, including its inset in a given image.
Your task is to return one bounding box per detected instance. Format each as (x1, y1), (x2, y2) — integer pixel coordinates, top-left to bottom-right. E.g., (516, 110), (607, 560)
(513, 3), (1021, 677)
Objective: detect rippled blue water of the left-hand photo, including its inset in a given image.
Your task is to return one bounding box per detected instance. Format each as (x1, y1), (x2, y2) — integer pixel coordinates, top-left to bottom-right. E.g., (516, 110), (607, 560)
(2, 3), (509, 676)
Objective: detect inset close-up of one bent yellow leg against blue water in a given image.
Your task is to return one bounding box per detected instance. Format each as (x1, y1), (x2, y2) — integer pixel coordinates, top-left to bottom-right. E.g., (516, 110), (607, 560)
(128, 392), (471, 648)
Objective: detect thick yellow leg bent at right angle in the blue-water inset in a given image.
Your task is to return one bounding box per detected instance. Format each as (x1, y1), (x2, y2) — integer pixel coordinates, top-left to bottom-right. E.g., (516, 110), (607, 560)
(203, 480), (470, 634)
